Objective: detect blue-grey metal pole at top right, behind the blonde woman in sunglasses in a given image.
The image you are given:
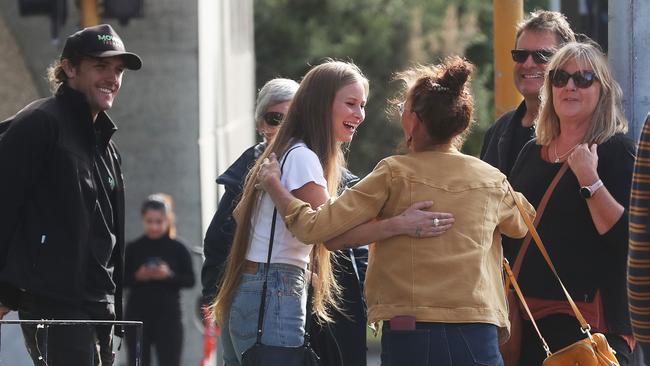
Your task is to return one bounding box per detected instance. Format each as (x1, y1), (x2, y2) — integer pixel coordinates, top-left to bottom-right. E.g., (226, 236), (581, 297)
(608, 0), (650, 141)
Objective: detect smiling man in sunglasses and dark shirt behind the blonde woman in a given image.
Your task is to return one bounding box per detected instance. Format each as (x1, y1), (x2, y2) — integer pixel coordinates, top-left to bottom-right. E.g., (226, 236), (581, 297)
(481, 10), (575, 176)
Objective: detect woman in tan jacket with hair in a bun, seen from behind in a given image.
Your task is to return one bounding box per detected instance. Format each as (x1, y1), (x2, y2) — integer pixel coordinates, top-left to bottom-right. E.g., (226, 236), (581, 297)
(258, 57), (534, 365)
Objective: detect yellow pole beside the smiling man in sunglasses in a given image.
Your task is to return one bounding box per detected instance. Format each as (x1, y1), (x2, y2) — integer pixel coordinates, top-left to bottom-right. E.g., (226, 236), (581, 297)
(492, 0), (524, 116)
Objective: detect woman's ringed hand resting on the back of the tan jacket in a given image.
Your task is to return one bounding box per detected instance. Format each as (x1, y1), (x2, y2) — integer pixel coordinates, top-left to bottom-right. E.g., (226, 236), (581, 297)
(390, 201), (455, 238)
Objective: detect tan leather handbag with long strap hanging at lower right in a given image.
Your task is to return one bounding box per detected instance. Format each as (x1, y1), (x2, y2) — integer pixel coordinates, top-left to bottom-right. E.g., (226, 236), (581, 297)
(503, 187), (620, 366)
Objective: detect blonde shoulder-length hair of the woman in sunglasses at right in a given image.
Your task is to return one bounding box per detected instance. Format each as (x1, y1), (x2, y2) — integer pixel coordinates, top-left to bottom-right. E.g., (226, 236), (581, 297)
(536, 42), (627, 145)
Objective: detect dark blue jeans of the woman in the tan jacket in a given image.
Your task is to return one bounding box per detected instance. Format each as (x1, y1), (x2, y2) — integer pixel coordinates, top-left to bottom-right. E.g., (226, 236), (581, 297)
(381, 321), (503, 366)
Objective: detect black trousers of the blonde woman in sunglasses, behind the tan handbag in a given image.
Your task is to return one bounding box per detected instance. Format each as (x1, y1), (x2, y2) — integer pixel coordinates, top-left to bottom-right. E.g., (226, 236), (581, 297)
(519, 314), (632, 366)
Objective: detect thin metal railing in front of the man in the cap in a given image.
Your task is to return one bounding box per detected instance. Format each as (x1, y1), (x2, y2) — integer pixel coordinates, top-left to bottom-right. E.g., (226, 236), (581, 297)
(0, 319), (142, 366)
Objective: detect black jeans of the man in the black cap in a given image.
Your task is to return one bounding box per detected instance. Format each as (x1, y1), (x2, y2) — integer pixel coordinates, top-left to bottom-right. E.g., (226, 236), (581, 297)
(18, 296), (115, 366)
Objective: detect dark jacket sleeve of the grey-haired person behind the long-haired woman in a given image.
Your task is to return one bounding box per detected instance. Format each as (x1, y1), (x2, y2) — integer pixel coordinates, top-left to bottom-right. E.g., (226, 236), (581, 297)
(201, 187), (239, 304)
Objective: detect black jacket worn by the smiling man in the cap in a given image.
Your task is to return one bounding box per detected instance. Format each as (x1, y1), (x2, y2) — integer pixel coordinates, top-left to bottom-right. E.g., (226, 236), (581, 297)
(0, 85), (124, 319)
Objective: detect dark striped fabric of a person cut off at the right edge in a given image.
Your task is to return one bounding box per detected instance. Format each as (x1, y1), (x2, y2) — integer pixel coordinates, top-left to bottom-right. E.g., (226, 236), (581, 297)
(627, 113), (650, 355)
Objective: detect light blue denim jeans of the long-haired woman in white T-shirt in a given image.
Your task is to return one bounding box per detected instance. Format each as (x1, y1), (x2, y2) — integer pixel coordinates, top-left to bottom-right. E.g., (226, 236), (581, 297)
(221, 263), (307, 366)
